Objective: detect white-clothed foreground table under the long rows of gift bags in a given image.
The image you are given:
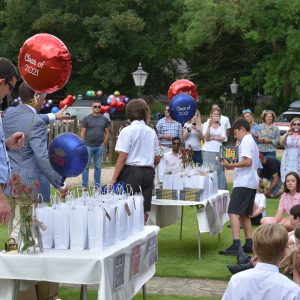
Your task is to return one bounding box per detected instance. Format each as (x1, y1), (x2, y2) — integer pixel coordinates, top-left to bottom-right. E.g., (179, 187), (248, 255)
(0, 226), (159, 300)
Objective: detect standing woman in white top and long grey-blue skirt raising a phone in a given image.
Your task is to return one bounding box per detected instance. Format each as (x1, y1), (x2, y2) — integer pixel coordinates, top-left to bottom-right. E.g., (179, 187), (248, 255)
(202, 108), (227, 190)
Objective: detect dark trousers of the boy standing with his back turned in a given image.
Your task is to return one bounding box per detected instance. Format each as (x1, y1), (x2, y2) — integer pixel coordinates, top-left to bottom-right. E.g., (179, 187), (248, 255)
(118, 165), (155, 211)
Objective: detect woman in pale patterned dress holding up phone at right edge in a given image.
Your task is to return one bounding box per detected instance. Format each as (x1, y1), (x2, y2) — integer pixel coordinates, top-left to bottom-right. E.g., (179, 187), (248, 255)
(280, 118), (300, 182)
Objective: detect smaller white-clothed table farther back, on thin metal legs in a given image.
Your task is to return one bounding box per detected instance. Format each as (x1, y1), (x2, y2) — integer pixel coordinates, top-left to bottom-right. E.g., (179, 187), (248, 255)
(148, 190), (230, 259)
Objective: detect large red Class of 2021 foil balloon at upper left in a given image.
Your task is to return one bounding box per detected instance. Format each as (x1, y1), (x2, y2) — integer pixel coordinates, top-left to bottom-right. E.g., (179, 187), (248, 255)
(18, 33), (72, 94)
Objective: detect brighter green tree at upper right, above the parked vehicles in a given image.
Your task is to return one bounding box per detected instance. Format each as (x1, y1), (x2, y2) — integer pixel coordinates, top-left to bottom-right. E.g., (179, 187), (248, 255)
(175, 0), (300, 112)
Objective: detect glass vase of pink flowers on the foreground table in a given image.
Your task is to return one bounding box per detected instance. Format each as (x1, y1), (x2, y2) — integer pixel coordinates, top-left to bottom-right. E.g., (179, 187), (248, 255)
(8, 174), (39, 252)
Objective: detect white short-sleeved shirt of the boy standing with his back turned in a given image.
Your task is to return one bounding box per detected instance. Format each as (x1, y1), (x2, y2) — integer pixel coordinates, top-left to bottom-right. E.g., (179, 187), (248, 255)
(115, 120), (159, 167)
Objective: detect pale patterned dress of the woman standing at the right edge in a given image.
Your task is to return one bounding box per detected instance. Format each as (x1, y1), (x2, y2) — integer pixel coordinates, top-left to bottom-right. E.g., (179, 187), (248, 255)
(280, 135), (300, 182)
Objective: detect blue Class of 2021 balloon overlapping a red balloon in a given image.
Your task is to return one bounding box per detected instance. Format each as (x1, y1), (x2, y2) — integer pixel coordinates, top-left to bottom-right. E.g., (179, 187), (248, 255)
(169, 94), (196, 124)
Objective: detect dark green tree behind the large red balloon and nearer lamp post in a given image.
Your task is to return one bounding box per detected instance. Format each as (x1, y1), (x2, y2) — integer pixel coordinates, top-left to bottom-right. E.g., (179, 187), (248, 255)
(0, 0), (179, 95)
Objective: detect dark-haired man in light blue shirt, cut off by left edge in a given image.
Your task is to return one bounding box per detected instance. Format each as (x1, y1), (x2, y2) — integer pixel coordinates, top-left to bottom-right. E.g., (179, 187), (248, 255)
(0, 57), (24, 224)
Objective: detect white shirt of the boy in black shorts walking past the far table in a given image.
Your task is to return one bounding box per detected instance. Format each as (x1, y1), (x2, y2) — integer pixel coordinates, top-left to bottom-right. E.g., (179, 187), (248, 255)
(233, 133), (259, 190)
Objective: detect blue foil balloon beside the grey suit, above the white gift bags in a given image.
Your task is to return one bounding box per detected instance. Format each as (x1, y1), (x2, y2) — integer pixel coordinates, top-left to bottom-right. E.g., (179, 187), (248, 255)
(49, 132), (88, 178)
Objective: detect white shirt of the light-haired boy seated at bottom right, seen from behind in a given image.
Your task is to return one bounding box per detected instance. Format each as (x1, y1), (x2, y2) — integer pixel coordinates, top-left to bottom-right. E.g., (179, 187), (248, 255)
(222, 263), (300, 300)
